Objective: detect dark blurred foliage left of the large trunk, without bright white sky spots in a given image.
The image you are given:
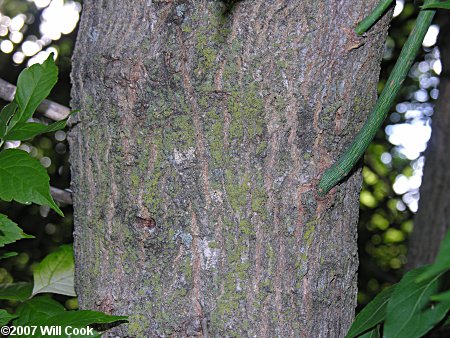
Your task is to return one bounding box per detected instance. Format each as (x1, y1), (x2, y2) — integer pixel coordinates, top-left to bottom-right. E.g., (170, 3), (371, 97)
(0, 0), (78, 309)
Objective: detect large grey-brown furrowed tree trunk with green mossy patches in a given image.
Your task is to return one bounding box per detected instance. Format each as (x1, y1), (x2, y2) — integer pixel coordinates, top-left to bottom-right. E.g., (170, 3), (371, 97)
(70, 0), (389, 337)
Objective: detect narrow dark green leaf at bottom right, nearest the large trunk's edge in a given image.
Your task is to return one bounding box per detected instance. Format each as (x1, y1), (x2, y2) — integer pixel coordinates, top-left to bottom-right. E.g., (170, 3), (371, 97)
(345, 285), (395, 338)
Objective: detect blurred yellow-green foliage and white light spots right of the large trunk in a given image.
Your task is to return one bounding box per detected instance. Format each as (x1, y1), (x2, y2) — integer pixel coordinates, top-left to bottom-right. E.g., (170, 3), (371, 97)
(358, 2), (440, 305)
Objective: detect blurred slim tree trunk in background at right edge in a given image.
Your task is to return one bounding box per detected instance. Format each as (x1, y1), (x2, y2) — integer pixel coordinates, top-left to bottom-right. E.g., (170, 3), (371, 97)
(408, 12), (450, 268)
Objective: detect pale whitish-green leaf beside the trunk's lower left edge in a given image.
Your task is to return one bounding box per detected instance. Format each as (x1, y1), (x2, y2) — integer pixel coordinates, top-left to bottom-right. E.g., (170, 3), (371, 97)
(33, 245), (76, 296)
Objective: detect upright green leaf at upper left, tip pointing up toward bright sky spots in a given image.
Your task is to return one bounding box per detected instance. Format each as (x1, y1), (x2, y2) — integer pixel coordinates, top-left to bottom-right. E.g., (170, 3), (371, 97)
(11, 54), (58, 127)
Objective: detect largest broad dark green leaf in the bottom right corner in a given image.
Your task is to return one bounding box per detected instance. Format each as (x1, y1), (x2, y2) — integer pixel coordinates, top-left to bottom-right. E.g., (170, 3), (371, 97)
(383, 267), (448, 338)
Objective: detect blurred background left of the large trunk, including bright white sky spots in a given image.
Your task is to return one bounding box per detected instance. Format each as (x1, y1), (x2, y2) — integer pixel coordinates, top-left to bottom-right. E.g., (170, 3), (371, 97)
(0, 0), (81, 309)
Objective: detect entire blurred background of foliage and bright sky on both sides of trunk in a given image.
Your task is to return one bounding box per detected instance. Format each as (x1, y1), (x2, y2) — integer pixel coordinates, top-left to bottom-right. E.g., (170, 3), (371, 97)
(0, 0), (442, 309)
